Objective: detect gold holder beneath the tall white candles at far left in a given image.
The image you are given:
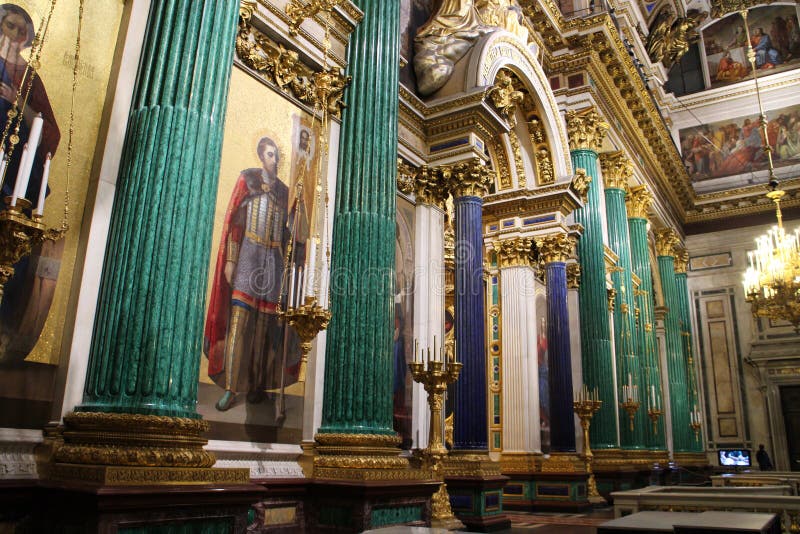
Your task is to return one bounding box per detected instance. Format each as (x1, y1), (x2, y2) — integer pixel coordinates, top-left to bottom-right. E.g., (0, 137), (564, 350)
(0, 197), (67, 302)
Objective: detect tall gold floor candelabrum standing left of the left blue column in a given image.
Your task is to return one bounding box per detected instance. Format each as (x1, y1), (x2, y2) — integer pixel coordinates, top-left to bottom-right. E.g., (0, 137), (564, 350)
(408, 340), (463, 529)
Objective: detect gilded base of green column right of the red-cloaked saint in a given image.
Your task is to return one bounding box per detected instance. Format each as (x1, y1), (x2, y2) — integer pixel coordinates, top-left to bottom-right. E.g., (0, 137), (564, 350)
(314, 434), (435, 481)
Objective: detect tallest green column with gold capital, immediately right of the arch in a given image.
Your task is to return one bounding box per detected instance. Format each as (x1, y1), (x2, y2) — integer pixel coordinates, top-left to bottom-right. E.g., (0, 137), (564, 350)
(566, 108), (619, 450)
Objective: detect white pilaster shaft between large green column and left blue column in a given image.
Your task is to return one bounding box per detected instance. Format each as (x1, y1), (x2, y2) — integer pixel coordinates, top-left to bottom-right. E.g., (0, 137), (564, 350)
(411, 202), (445, 448)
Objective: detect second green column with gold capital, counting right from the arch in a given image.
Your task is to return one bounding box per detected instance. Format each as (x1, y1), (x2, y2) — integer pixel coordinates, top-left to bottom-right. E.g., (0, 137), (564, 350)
(600, 152), (648, 449)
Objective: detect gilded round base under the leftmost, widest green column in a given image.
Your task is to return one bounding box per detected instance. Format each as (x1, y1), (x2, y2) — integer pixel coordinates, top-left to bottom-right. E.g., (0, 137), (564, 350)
(54, 412), (216, 468)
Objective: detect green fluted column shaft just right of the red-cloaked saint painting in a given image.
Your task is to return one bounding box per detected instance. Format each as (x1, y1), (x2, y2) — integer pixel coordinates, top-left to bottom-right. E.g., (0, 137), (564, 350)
(319, 0), (400, 436)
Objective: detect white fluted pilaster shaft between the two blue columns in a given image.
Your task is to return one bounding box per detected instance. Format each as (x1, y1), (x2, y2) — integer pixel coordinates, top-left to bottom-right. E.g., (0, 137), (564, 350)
(500, 266), (542, 453)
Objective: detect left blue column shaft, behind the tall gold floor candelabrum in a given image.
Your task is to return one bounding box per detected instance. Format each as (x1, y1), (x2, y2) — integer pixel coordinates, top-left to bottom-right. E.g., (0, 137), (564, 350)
(453, 196), (488, 450)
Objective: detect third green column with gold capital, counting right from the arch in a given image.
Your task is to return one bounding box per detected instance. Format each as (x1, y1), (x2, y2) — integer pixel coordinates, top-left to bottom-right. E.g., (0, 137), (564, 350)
(626, 186), (666, 451)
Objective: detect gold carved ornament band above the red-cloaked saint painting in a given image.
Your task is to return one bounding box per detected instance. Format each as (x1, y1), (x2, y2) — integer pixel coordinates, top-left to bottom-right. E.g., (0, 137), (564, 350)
(236, 5), (351, 117)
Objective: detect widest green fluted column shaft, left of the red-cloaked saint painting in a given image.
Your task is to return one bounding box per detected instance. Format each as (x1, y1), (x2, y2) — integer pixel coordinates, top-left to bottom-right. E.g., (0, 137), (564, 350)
(76, 0), (239, 418)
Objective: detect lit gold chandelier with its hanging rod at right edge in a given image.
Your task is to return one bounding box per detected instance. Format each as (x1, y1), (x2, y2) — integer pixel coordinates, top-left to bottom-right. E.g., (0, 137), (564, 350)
(741, 10), (800, 330)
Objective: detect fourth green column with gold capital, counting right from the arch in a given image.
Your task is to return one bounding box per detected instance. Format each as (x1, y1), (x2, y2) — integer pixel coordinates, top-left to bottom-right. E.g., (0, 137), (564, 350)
(656, 228), (694, 452)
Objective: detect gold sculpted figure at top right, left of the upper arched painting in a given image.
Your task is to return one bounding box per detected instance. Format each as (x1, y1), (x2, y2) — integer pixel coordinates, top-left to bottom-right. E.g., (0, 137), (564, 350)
(646, 8), (708, 69)
